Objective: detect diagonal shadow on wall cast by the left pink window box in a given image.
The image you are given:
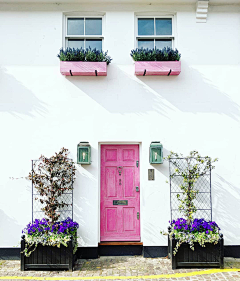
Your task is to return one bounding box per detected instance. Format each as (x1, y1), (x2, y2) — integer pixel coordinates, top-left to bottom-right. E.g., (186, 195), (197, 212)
(66, 64), (171, 117)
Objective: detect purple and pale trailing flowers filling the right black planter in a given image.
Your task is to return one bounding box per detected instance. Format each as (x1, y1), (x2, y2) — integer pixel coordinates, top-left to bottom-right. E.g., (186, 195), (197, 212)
(169, 218), (220, 255)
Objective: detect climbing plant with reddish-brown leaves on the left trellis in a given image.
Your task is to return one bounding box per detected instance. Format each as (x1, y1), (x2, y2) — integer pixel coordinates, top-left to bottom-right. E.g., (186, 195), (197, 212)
(28, 148), (76, 225)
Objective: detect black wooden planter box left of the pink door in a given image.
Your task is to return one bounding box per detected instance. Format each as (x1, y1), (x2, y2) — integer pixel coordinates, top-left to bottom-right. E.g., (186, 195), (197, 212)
(21, 235), (75, 271)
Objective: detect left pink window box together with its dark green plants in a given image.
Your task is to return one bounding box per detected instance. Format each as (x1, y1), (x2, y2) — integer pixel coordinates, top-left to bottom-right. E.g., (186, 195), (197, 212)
(58, 48), (112, 76)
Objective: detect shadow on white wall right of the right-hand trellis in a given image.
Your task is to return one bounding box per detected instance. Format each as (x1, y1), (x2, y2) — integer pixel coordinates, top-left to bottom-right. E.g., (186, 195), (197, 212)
(212, 174), (240, 245)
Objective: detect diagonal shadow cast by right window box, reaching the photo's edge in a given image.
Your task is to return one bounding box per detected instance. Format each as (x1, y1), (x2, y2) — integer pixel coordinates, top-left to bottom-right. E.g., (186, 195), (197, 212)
(139, 61), (240, 120)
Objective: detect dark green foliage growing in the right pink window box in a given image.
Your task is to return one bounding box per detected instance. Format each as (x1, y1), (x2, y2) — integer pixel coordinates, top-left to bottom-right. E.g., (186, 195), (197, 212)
(130, 47), (181, 61)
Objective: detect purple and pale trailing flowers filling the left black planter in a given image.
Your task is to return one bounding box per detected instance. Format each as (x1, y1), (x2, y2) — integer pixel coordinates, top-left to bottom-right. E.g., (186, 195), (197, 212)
(22, 218), (79, 257)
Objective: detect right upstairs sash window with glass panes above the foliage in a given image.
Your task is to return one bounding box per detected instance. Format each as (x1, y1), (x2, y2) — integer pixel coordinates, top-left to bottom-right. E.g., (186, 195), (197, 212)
(137, 17), (174, 49)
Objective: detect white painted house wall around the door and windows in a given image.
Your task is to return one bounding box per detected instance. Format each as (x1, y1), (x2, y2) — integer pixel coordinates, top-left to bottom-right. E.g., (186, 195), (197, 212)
(0, 4), (240, 247)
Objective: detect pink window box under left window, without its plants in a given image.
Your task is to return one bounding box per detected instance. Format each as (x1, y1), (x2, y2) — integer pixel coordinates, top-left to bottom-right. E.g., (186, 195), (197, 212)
(60, 61), (107, 76)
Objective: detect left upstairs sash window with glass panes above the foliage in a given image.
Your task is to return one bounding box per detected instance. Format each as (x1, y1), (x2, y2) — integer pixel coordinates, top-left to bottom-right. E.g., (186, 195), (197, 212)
(65, 17), (103, 50)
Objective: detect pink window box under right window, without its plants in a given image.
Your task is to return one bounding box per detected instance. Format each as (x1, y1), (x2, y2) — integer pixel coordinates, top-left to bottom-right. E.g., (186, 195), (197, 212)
(135, 61), (181, 76)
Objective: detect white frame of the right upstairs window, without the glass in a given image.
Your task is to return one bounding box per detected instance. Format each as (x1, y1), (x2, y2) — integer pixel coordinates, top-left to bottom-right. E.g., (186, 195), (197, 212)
(135, 14), (176, 49)
